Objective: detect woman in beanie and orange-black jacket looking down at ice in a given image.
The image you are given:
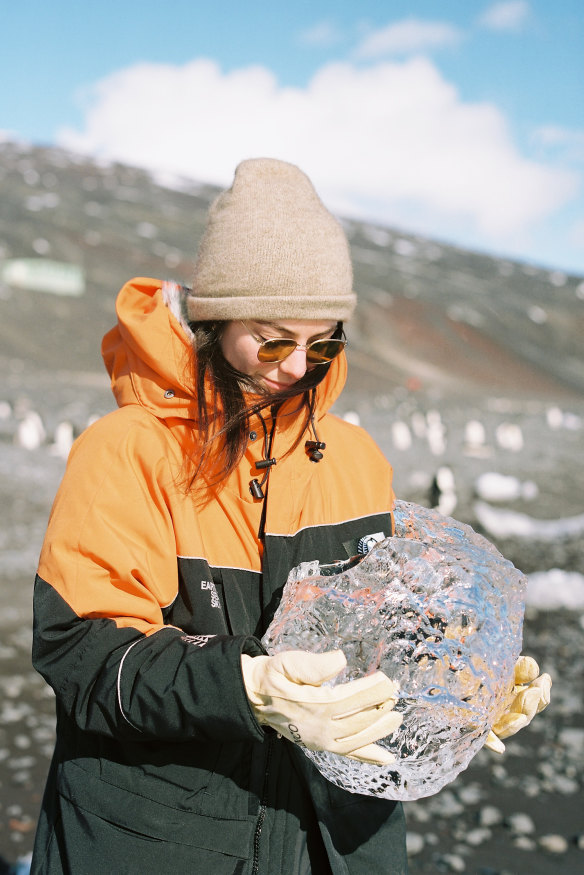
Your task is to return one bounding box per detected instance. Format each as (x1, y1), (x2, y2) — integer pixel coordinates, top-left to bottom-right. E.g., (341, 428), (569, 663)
(32, 159), (548, 875)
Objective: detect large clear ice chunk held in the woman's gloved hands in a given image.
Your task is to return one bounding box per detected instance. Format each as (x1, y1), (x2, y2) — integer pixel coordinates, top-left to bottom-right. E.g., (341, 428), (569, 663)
(262, 501), (527, 800)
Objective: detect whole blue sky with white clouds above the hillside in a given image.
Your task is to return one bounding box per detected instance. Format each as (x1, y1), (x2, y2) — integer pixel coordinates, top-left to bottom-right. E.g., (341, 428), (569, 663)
(0, 0), (584, 274)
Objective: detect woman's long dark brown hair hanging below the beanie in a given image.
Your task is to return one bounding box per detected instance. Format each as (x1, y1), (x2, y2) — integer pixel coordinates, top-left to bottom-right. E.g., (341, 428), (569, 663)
(189, 320), (343, 488)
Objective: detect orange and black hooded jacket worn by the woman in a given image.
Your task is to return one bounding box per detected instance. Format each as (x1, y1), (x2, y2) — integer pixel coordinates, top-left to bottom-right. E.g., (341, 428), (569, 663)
(32, 279), (406, 875)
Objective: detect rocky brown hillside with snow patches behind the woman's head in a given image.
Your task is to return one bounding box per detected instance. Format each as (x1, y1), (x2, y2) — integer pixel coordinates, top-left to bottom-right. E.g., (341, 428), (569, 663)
(0, 142), (584, 399)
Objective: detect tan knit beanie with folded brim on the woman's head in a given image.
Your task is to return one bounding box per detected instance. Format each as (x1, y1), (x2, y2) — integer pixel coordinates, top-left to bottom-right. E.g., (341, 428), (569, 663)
(187, 158), (356, 321)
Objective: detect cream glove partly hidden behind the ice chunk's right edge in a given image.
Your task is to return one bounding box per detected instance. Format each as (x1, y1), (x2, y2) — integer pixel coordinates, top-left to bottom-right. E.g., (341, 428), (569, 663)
(485, 656), (552, 753)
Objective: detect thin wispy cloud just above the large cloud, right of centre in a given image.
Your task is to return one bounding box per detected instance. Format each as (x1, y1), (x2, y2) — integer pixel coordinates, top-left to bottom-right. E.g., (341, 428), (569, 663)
(355, 18), (462, 58)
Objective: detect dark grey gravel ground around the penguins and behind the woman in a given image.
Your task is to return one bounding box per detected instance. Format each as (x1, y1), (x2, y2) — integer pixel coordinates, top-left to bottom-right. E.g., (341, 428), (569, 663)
(0, 392), (584, 875)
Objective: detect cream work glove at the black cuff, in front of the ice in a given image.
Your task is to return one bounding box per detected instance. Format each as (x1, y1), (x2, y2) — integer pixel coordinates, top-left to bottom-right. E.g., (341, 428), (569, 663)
(241, 650), (402, 765)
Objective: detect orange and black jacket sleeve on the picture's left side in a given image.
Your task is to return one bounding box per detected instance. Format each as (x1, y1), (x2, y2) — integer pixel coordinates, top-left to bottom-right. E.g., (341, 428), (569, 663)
(33, 417), (264, 741)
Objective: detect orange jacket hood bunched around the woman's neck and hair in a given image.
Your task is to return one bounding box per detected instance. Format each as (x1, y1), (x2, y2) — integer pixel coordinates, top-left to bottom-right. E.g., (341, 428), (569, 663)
(101, 278), (347, 420)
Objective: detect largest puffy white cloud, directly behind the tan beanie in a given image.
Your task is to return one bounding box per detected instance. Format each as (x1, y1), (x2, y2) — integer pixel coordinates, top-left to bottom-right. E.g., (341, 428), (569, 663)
(58, 57), (578, 247)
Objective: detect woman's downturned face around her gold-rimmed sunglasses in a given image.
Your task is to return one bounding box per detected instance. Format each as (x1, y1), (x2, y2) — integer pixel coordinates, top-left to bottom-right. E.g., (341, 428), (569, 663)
(221, 319), (337, 392)
